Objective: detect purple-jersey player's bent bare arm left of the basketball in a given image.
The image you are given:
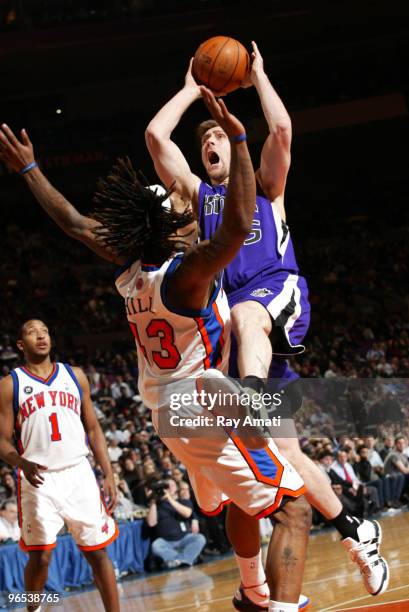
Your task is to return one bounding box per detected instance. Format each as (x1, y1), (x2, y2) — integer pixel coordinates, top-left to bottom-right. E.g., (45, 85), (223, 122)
(145, 60), (200, 202)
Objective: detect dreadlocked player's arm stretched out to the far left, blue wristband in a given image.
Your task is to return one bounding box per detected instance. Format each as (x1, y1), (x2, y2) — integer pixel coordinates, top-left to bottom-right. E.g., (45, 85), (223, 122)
(0, 123), (125, 264)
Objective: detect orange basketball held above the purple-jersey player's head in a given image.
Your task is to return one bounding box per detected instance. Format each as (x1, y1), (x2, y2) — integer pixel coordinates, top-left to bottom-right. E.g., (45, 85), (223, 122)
(193, 36), (250, 93)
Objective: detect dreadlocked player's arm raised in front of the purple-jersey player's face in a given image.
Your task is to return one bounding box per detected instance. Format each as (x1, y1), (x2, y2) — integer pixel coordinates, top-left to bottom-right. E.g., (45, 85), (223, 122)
(172, 87), (256, 308)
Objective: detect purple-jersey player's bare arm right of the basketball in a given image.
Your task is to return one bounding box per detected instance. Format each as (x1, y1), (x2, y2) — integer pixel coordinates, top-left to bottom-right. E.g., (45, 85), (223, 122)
(244, 41), (292, 210)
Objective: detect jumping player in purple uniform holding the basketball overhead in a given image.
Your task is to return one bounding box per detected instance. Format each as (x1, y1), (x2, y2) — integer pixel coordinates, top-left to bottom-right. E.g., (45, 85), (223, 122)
(146, 42), (389, 609)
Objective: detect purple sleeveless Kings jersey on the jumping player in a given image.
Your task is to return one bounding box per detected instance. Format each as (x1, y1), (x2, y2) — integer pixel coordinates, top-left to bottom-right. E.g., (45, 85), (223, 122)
(199, 182), (298, 295)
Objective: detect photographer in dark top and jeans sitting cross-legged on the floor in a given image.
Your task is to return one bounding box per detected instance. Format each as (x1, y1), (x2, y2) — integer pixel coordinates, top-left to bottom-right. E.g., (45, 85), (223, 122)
(147, 478), (206, 568)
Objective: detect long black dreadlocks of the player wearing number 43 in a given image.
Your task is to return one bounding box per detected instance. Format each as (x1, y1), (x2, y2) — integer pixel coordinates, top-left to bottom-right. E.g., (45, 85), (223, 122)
(92, 157), (195, 263)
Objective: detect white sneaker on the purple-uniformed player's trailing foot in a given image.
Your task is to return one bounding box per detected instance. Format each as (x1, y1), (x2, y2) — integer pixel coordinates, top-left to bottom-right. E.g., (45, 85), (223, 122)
(342, 520), (389, 595)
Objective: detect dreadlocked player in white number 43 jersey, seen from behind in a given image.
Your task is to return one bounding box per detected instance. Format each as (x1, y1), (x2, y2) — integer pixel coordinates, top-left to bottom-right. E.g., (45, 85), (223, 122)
(0, 88), (310, 612)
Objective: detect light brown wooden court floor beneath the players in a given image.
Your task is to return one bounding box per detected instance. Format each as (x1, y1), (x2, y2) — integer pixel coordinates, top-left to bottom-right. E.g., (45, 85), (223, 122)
(47, 512), (409, 612)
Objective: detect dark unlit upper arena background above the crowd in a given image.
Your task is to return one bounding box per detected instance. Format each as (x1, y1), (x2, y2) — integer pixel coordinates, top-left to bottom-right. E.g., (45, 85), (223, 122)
(0, 0), (409, 354)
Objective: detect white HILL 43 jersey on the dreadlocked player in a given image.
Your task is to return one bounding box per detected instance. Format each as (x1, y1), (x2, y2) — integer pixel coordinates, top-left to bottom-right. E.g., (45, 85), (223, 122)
(116, 253), (230, 409)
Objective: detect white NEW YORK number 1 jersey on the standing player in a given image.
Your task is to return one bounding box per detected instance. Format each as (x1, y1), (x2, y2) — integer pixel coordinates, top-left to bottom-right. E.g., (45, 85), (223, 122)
(11, 363), (89, 471)
